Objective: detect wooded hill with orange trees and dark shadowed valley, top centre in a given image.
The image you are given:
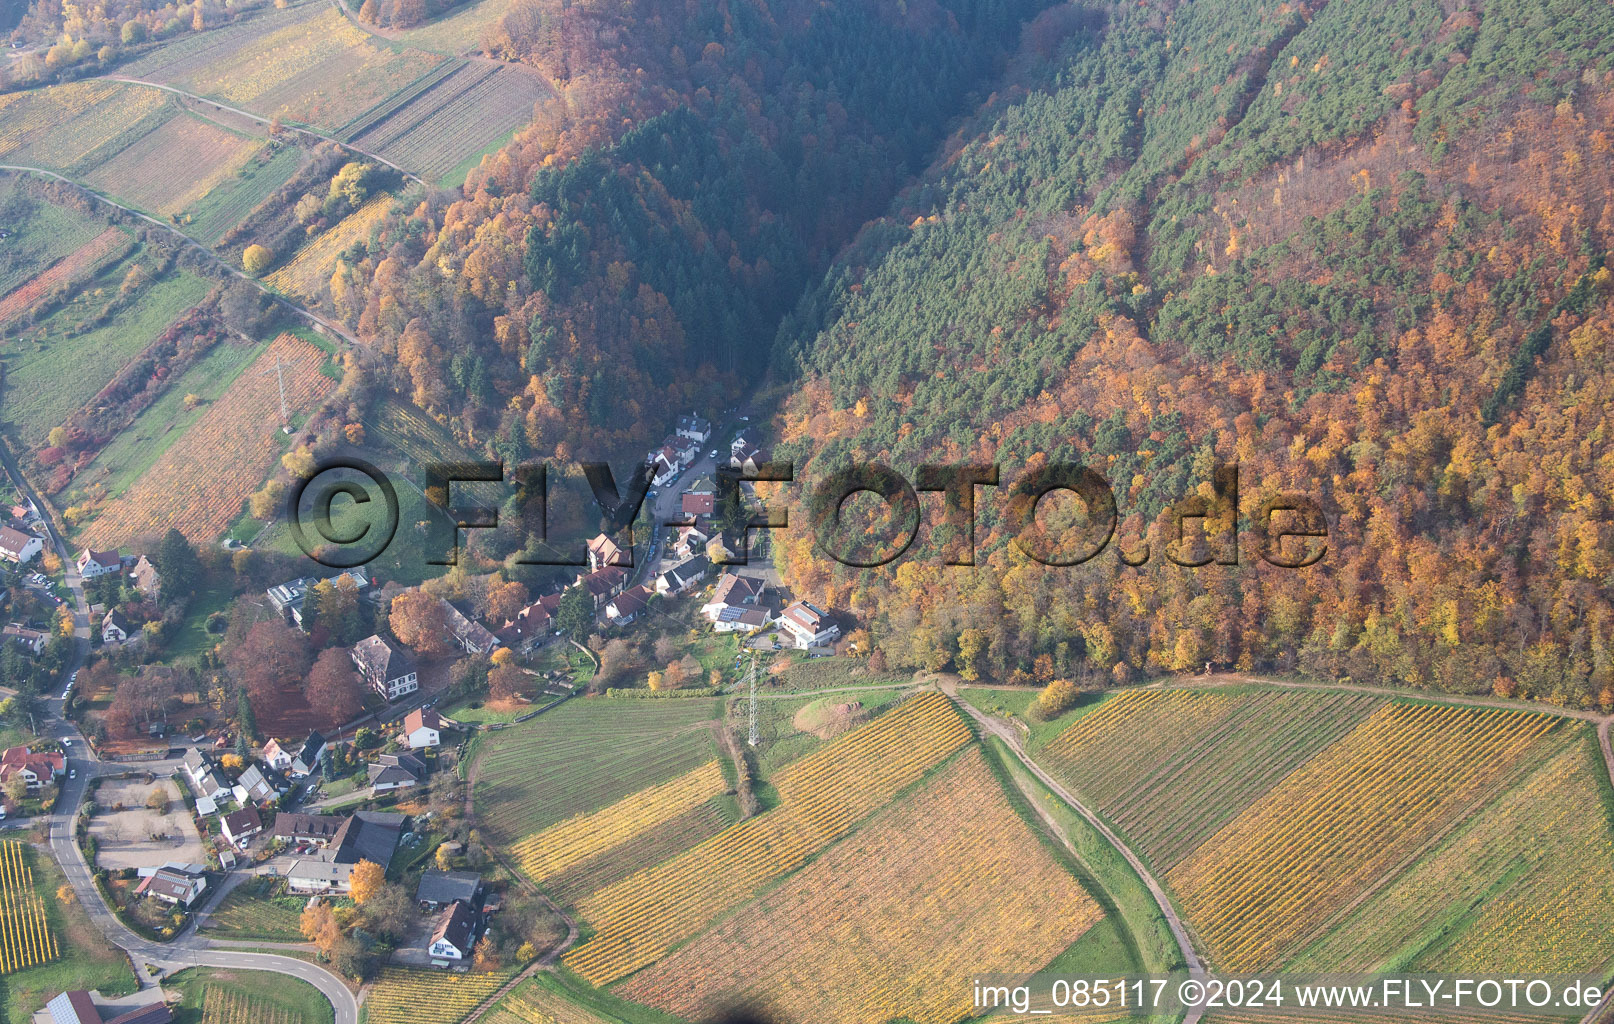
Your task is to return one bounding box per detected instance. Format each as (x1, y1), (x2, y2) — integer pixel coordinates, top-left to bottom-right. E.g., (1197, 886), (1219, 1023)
(340, 0), (1038, 459)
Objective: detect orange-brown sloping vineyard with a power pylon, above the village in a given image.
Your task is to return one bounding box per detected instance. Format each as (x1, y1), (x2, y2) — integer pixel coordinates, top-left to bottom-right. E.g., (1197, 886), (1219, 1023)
(79, 334), (336, 546)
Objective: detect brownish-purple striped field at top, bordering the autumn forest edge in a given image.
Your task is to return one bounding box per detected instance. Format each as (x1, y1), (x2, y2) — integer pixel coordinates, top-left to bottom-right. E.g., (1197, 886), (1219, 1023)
(353, 63), (547, 181)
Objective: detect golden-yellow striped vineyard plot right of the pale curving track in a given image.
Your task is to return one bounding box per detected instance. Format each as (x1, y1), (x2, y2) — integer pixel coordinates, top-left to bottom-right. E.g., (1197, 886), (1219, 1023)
(1165, 703), (1558, 972)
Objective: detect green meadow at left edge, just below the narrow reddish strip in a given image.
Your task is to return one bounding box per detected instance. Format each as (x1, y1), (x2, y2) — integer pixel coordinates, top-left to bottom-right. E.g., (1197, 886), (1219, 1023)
(0, 258), (210, 447)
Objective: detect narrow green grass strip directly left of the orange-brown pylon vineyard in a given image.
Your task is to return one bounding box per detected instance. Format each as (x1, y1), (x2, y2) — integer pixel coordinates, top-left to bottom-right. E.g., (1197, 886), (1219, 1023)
(74, 341), (265, 497)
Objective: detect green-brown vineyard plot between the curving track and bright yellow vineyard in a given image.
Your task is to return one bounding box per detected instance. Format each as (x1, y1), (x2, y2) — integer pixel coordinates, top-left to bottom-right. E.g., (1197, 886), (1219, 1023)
(1033, 688), (1385, 869)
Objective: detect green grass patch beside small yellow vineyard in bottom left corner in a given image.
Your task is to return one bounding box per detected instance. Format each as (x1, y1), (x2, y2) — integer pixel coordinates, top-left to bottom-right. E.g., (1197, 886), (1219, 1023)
(0, 850), (136, 1024)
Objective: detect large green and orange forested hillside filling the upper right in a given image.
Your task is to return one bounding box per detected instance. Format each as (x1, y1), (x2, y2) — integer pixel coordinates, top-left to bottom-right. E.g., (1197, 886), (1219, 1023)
(776, 0), (1614, 706)
